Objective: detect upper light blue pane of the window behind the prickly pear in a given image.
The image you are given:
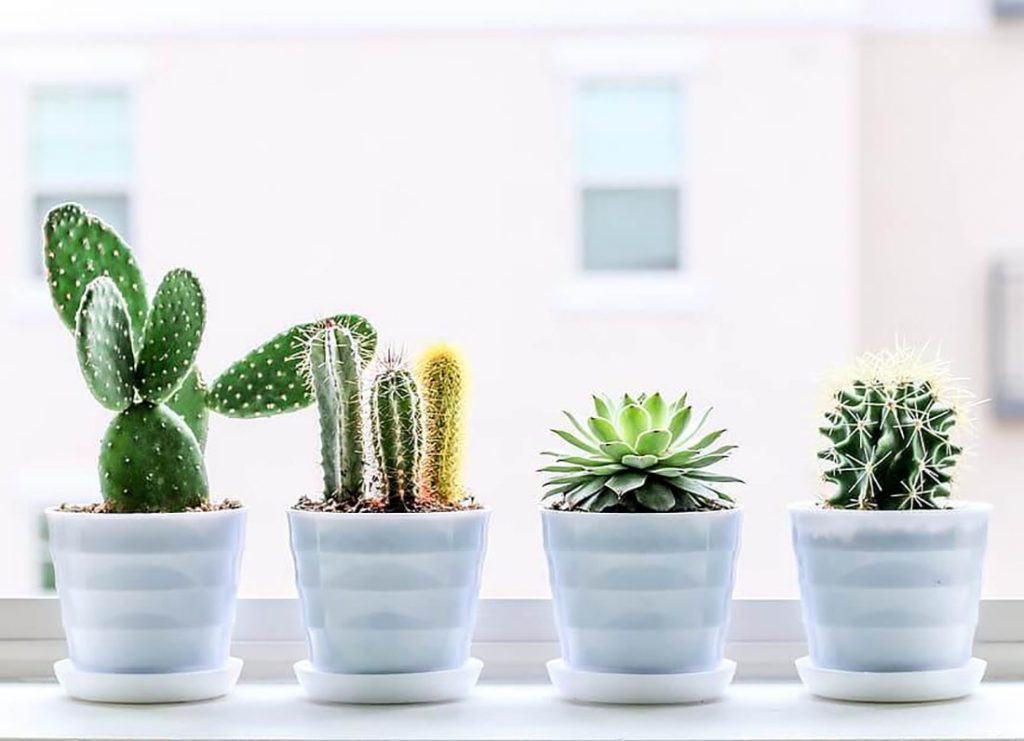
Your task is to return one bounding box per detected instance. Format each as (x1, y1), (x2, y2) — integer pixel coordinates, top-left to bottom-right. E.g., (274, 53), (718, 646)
(29, 88), (132, 185)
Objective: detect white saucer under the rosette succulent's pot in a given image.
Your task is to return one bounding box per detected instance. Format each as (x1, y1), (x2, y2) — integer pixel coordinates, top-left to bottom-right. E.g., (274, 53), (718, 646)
(548, 659), (736, 705)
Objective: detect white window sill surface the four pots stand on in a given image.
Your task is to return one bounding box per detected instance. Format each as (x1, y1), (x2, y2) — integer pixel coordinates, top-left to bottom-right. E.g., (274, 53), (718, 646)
(0, 682), (1024, 741)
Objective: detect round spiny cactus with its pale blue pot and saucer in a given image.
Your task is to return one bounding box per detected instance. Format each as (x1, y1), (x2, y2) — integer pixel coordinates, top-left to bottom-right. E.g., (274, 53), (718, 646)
(790, 349), (991, 700)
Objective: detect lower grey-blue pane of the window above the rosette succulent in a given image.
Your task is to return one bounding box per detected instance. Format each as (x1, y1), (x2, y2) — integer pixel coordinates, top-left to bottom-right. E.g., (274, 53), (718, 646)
(583, 188), (680, 270)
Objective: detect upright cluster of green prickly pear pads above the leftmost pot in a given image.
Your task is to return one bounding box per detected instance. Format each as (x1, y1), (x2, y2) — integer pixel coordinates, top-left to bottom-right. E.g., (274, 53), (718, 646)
(43, 204), (208, 512)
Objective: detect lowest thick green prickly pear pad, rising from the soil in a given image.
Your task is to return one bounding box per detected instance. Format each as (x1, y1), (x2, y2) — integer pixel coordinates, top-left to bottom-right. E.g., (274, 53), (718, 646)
(99, 401), (209, 512)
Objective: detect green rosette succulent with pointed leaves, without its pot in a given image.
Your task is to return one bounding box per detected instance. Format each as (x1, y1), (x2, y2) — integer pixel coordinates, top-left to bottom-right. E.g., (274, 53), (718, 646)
(541, 393), (742, 512)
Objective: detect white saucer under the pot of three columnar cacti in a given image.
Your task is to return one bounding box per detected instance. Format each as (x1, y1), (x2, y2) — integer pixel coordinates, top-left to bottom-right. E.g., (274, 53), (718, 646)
(295, 658), (483, 705)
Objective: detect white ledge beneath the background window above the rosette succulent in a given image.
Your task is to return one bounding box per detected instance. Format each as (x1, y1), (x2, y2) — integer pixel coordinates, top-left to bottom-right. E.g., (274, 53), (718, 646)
(555, 273), (708, 314)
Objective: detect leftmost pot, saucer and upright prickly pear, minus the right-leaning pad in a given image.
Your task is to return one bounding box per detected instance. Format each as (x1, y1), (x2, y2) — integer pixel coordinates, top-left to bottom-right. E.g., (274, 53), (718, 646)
(44, 204), (245, 701)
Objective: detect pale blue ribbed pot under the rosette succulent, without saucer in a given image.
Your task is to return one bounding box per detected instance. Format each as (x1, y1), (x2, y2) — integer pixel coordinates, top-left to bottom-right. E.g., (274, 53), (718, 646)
(541, 510), (742, 674)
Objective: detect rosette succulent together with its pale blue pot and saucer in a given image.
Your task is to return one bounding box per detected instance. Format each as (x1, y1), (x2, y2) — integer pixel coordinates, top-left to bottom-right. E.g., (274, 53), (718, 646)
(541, 393), (740, 703)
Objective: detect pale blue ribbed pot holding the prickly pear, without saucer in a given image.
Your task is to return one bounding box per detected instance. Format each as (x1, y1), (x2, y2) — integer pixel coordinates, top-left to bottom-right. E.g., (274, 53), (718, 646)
(46, 509), (246, 673)
